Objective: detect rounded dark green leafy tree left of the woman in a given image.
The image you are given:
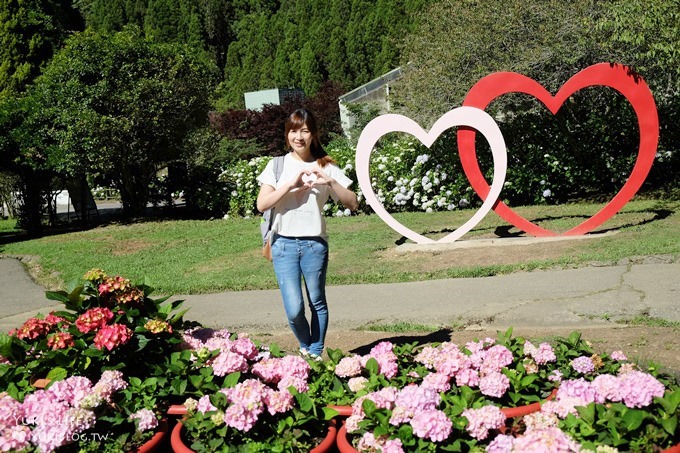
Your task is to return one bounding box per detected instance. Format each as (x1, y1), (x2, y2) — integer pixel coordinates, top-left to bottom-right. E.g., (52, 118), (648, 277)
(31, 28), (216, 215)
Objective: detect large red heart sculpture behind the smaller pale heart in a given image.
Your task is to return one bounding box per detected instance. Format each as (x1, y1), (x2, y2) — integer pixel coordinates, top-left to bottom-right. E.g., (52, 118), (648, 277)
(457, 63), (659, 237)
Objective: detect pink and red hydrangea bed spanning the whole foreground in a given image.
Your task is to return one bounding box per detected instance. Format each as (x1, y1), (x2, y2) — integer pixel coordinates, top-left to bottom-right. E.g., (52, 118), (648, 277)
(0, 270), (680, 452)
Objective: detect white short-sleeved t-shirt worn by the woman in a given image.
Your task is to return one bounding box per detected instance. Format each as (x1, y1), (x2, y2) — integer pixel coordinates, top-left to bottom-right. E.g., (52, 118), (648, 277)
(257, 153), (352, 239)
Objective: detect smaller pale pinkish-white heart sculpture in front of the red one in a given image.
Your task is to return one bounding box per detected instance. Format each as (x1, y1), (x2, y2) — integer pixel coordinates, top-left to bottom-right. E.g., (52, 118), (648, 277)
(356, 107), (508, 244)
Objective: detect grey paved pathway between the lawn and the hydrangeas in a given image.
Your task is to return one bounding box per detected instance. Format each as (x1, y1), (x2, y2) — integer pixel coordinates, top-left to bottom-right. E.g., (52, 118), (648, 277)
(0, 256), (680, 332)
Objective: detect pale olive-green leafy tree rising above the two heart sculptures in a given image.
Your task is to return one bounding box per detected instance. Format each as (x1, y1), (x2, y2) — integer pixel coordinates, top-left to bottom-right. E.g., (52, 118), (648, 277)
(393, 0), (599, 125)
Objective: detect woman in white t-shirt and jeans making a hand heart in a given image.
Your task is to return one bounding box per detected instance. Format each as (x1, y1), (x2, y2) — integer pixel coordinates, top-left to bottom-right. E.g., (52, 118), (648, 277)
(257, 109), (358, 358)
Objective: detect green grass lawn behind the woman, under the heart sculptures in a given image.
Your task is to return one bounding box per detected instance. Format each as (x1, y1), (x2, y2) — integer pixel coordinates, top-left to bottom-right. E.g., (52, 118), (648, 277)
(0, 200), (680, 295)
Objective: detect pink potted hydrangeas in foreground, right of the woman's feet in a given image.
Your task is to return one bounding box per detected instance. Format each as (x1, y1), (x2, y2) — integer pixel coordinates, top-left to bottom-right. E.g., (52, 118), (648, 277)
(322, 332), (680, 452)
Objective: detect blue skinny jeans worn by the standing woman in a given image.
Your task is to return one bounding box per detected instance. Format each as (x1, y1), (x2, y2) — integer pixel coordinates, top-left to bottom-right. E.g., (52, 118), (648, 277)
(272, 236), (328, 355)
